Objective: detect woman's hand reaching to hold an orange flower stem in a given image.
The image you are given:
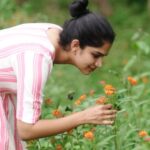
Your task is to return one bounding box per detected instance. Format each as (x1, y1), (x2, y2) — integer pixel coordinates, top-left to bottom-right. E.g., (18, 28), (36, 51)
(82, 104), (117, 125)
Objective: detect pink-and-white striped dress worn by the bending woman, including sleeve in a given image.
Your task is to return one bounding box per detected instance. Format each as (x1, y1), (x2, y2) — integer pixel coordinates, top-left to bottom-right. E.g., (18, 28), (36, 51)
(0, 23), (61, 150)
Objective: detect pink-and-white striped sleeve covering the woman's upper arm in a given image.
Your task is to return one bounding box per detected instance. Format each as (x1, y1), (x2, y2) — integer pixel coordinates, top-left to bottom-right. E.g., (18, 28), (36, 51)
(15, 52), (52, 124)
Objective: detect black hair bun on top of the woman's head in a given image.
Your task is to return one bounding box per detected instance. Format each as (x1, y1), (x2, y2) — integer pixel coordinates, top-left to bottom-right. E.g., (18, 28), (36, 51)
(69, 0), (89, 18)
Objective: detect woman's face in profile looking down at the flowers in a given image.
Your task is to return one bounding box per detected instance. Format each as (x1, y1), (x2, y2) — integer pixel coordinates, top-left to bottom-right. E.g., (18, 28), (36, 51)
(74, 42), (111, 75)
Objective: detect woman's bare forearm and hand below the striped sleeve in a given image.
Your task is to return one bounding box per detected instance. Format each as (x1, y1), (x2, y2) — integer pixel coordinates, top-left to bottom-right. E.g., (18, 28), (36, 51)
(17, 105), (116, 140)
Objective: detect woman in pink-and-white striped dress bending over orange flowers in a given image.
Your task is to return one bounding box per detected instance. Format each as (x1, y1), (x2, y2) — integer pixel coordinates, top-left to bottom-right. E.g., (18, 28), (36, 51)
(0, 0), (116, 150)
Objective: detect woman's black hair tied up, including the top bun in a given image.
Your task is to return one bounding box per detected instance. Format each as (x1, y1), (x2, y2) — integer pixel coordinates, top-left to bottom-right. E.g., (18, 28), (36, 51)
(60, 0), (115, 49)
